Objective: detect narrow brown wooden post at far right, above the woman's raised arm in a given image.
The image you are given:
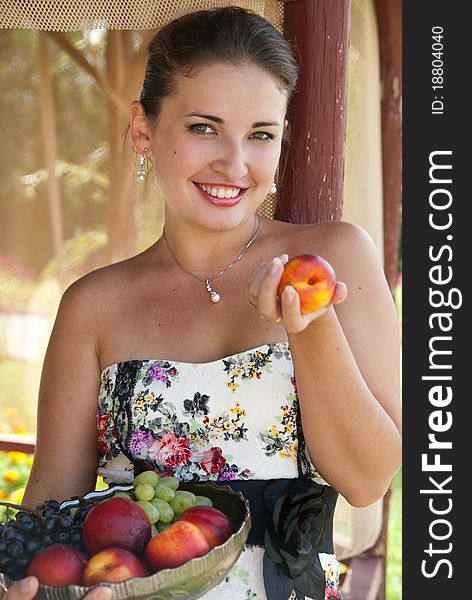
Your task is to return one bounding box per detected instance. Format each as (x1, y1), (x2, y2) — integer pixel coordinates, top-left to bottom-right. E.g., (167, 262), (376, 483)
(375, 0), (402, 293)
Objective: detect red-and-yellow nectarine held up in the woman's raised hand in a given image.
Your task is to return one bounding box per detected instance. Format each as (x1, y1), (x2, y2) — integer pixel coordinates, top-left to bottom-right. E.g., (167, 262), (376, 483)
(277, 254), (336, 314)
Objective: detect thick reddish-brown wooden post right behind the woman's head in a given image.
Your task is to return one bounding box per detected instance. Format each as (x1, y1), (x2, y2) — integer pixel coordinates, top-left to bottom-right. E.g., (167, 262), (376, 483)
(275, 0), (351, 223)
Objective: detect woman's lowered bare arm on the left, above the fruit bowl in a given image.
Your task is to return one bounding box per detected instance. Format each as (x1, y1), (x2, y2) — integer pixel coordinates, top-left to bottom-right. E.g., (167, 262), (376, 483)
(23, 273), (103, 508)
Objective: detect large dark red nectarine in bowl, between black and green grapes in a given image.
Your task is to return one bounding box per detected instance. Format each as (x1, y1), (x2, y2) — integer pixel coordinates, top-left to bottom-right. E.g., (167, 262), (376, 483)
(82, 498), (151, 554)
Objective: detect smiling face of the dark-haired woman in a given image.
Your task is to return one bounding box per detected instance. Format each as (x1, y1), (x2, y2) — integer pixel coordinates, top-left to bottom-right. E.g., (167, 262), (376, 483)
(150, 64), (287, 229)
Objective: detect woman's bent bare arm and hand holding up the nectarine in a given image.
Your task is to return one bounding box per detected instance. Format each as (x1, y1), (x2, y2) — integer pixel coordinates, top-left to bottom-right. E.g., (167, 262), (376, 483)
(249, 223), (401, 506)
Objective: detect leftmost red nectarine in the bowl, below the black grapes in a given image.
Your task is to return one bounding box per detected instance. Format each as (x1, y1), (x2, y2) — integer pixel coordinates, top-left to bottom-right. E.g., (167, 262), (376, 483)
(27, 544), (87, 587)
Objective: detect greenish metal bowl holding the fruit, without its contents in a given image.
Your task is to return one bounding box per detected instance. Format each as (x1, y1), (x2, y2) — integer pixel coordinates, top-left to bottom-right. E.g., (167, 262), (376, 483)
(2, 482), (251, 600)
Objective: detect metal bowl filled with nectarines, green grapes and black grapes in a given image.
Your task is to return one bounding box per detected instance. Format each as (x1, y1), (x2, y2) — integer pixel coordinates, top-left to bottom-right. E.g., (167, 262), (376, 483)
(0, 471), (251, 600)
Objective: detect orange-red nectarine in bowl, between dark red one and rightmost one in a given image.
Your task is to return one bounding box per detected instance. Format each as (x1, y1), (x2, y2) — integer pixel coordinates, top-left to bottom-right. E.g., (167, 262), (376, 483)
(144, 520), (210, 573)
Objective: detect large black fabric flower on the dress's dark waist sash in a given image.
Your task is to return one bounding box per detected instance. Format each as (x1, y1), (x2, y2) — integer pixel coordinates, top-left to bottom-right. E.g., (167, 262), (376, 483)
(264, 479), (331, 600)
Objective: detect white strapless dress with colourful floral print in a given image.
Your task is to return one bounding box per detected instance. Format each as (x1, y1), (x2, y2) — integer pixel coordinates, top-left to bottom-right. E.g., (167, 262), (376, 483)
(97, 342), (341, 600)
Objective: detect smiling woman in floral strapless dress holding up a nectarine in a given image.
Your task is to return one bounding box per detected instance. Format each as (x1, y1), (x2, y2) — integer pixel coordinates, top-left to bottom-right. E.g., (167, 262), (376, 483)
(6, 8), (401, 600)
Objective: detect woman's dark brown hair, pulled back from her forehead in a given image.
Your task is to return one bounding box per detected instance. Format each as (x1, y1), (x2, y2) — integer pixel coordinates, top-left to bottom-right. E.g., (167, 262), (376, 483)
(140, 7), (298, 120)
